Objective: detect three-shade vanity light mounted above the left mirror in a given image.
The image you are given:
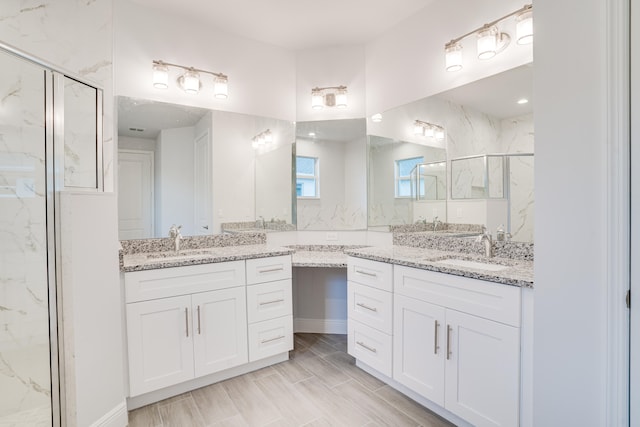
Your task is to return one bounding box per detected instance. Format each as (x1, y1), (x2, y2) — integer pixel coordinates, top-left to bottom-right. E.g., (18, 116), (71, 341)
(152, 59), (229, 99)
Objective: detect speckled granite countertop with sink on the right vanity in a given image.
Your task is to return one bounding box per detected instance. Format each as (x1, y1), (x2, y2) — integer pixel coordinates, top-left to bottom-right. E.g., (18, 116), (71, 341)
(345, 245), (533, 288)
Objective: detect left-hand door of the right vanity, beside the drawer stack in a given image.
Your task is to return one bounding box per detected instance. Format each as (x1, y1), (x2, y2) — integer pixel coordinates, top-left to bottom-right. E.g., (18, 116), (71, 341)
(393, 295), (446, 406)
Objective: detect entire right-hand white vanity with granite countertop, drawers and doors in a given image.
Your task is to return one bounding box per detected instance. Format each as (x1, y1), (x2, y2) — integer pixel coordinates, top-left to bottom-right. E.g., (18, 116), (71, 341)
(347, 246), (533, 426)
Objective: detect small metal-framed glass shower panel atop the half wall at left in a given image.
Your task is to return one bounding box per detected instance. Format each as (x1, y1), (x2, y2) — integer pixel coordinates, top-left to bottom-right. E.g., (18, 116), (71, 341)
(64, 76), (101, 189)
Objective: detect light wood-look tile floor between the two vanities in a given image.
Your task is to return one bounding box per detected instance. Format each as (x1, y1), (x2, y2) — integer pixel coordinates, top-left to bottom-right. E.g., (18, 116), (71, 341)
(129, 334), (453, 427)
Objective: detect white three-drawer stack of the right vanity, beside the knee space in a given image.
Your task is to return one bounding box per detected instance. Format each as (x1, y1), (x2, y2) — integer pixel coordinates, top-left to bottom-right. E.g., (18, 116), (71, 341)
(347, 257), (393, 376)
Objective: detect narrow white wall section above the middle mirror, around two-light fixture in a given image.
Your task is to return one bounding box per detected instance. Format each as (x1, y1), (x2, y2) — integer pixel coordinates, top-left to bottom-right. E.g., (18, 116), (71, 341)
(296, 45), (365, 122)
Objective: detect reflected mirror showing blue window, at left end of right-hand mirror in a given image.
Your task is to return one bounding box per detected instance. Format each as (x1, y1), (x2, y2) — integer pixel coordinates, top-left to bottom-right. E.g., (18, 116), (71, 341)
(368, 135), (446, 230)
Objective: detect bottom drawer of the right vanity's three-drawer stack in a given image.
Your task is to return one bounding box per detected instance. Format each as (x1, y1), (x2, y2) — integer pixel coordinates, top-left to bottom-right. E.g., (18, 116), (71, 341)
(347, 319), (393, 377)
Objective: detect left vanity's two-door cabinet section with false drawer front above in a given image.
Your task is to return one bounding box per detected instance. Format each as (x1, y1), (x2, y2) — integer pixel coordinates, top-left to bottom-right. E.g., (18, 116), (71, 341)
(124, 261), (248, 396)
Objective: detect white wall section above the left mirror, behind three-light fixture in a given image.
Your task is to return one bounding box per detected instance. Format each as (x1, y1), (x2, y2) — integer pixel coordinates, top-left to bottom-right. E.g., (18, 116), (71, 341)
(114, 0), (296, 120)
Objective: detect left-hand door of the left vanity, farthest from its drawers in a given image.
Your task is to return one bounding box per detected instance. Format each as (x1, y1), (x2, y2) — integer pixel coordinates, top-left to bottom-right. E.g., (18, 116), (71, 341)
(127, 295), (194, 396)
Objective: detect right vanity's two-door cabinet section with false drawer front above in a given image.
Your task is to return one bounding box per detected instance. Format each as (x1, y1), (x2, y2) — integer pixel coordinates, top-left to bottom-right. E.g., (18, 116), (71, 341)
(393, 266), (521, 426)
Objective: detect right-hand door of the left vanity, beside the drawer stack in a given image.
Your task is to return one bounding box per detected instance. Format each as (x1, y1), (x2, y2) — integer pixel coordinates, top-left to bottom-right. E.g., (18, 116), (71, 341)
(191, 287), (248, 377)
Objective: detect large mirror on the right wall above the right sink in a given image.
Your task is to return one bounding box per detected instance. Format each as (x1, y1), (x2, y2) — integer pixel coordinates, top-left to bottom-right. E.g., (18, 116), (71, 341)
(367, 64), (534, 242)
